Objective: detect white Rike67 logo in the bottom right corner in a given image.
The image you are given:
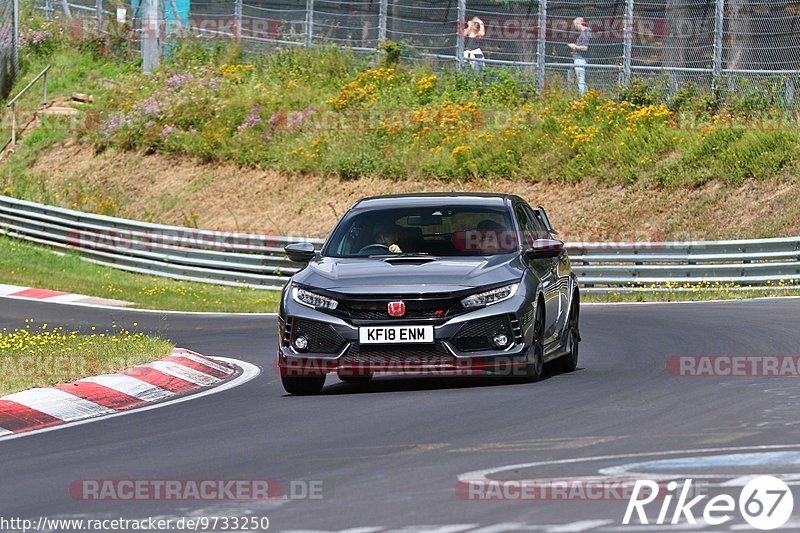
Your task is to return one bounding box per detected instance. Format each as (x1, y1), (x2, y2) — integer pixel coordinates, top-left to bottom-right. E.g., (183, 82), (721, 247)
(622, 476), (794, 530)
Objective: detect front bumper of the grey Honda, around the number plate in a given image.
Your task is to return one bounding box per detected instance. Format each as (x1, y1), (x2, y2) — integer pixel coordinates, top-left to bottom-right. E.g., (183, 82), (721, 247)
(277, 296), (535, 376)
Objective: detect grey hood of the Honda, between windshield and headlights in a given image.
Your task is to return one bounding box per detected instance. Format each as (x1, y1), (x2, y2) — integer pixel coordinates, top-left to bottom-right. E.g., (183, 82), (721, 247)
(292, 254), (524, 294)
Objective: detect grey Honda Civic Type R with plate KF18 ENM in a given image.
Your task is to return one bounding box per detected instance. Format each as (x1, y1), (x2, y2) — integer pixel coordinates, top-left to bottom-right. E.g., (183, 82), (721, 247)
(278, 193), (580, 394)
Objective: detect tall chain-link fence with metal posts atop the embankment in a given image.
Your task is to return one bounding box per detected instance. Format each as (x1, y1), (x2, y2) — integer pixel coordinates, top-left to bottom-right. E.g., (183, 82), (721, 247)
(31, 0), (800, 107)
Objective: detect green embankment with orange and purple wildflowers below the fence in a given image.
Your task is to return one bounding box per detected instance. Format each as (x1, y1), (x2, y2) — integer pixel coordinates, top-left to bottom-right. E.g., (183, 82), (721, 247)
(4, 17), (800, 200)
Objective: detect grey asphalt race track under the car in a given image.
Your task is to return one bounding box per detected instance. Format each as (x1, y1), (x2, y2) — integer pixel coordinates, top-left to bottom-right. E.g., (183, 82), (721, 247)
(0, 299), (800, 533)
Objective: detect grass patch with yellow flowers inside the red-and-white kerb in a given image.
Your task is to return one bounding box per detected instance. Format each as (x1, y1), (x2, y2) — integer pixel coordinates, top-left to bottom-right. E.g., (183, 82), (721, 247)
(0, 319), (174, 395)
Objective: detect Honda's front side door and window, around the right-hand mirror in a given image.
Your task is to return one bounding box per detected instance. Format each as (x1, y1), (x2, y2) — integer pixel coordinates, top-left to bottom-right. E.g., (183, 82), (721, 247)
(514, 202), (561, 342)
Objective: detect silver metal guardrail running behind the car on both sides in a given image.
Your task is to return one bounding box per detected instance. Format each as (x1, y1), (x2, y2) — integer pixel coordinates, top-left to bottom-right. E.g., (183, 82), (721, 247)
(0, 196), (800, 292)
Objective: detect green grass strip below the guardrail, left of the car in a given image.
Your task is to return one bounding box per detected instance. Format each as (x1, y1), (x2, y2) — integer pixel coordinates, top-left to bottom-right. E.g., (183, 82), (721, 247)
(0, 237), (279, 313)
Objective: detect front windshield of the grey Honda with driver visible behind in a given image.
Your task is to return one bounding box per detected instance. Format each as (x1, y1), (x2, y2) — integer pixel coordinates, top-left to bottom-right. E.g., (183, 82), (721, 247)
(325, 205), (517, 257)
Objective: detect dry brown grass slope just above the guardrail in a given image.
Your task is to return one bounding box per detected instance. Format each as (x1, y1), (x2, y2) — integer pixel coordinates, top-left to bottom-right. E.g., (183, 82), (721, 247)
(29, 141), (800, 241)
